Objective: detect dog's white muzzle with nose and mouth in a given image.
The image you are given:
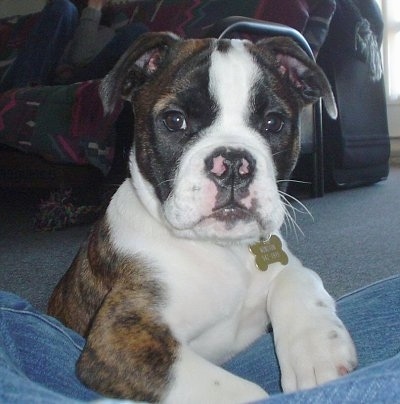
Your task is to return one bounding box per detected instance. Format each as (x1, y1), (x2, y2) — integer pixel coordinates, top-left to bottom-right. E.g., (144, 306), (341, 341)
(163, 136), (284, 243)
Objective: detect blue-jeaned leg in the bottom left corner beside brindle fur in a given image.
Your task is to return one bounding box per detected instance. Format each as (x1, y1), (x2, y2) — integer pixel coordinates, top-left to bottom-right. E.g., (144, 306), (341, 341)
(0, 292), (100, 403)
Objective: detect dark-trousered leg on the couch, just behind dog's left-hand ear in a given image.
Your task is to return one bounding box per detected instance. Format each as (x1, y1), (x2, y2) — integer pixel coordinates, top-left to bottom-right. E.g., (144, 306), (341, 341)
(73, 23), (148, 82)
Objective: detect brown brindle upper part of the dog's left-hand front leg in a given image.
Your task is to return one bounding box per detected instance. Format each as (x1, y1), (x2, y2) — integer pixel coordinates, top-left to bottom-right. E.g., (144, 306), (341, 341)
(77, 279), (178, 402)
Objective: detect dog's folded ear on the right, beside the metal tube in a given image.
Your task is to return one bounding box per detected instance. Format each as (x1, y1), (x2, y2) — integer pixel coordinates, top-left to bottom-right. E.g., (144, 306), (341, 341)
(257, 37), (337, 119)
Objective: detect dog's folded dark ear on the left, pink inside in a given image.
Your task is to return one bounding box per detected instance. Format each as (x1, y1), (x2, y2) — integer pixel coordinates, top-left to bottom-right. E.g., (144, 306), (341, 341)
(99, 32), (181, 115)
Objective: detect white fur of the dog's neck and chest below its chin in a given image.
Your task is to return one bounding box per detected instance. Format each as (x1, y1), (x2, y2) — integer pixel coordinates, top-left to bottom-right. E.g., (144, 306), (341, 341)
(107, 167), (283, 362)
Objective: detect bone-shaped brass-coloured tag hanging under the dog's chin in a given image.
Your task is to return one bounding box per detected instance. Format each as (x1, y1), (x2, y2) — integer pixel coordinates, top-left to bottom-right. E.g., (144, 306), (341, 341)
(249, 234), (289, 271)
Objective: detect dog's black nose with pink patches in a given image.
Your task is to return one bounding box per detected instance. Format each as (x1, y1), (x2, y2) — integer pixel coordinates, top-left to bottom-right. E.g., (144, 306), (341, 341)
(205, 148), (256, 189)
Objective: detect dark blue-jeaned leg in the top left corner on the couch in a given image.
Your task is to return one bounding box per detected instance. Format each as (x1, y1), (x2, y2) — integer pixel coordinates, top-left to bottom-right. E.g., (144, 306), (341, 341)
(0, 0), (79, 91)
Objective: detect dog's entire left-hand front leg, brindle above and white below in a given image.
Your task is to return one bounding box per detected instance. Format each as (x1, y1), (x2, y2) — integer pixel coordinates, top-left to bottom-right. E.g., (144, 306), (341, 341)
(78, 282), (267, 404)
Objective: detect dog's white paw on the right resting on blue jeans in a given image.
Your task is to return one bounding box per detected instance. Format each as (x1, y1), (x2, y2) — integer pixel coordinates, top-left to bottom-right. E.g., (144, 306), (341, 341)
(275, 315), (357, 392)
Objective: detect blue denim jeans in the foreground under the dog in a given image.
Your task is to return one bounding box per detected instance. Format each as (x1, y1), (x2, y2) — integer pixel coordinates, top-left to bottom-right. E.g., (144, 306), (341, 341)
(0, 276), (400, 404)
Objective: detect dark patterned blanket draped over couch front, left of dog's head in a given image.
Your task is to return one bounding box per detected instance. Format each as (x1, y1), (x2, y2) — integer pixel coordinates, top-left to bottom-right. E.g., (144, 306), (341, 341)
(0, 81), (121, 174)
